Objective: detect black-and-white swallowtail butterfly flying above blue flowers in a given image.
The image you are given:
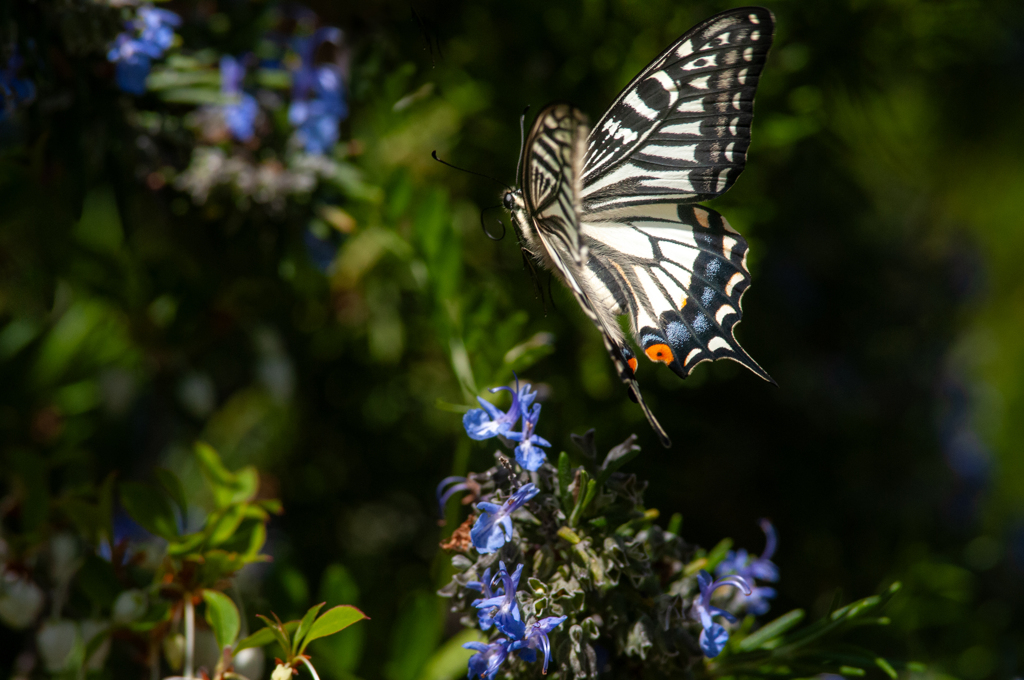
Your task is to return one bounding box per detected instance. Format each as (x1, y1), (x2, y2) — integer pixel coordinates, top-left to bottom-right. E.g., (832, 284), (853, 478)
(503, 7), (775, 448)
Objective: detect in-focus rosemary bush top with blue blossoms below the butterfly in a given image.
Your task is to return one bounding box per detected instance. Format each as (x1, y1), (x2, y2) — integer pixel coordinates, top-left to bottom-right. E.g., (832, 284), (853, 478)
(437, 380), (806, 680)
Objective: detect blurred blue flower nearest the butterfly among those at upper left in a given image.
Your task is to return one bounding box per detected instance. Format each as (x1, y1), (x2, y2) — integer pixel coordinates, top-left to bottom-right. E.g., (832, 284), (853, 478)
(288, 27), (348, 155)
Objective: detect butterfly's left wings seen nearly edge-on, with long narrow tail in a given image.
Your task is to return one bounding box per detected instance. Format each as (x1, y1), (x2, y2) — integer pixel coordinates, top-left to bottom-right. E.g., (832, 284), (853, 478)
(521, 103), (672, 447)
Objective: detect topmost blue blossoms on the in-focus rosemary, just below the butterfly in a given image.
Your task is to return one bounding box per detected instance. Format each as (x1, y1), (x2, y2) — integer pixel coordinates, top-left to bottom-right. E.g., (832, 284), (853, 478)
(462, 379), (551, 472)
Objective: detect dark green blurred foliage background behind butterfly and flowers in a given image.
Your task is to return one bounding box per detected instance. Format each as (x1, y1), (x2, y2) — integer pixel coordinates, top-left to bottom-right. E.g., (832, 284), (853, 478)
(0, 0), (1024, 680)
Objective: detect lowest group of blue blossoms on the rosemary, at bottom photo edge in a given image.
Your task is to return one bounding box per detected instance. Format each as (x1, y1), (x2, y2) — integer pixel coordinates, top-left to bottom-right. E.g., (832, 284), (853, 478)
(463, 562), (567, 680)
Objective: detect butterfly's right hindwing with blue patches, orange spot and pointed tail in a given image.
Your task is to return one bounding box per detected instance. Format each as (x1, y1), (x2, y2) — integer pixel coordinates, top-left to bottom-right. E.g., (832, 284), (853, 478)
(581, 203), (774, 382)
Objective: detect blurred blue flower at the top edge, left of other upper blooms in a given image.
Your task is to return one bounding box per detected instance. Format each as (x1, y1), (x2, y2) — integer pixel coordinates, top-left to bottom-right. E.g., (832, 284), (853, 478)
(106, 5), (181, 95)
